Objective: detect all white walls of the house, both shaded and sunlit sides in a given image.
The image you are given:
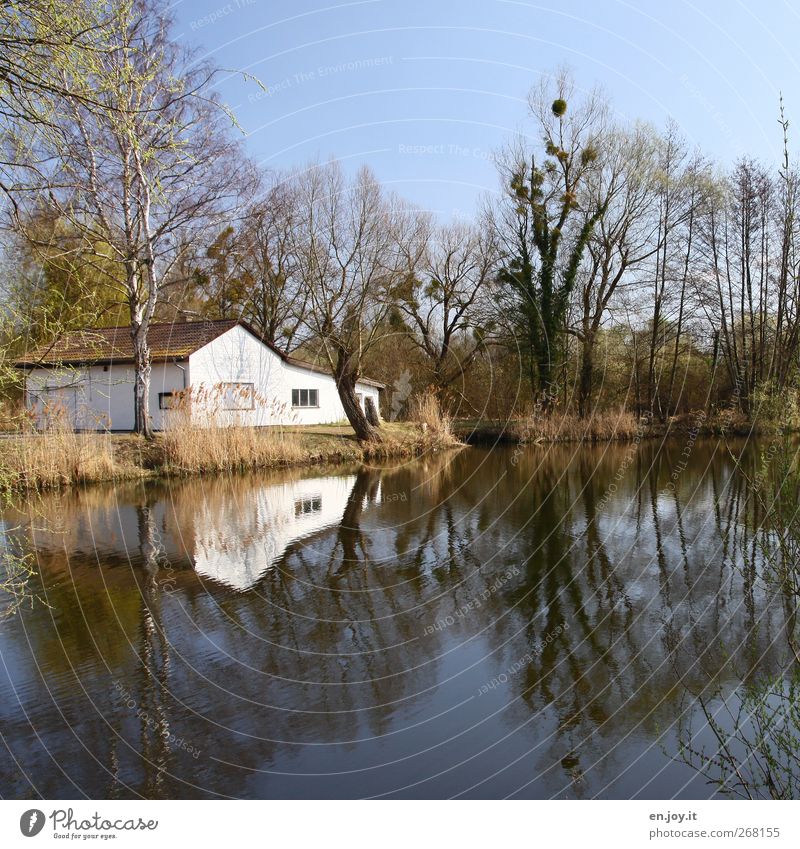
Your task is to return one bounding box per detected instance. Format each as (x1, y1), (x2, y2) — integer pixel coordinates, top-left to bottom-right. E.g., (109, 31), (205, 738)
(27, 327), (379, 430)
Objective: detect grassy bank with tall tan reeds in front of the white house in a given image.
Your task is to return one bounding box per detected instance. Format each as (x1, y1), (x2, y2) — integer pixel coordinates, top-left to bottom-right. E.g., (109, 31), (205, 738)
(0, 422), (459, 492)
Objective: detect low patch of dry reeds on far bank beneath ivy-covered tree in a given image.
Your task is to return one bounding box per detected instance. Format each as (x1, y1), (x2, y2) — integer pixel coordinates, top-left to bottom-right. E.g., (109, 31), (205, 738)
(509, 409), (647, 442)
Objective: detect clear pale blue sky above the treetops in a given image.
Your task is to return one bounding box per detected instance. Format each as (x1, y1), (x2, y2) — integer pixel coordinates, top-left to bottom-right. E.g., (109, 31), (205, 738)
(173, 0), (800, 217)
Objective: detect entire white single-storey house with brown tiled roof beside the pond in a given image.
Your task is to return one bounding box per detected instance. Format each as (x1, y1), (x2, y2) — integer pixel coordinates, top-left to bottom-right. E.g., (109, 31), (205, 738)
(17, 319), (383, 431)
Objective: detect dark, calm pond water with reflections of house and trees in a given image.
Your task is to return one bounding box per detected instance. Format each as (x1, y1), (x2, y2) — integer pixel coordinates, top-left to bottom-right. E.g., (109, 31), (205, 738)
(0, 440), (787, 798)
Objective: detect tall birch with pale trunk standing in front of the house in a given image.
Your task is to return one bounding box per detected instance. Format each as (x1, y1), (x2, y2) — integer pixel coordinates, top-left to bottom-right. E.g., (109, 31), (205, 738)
(15, 0), (252, 437)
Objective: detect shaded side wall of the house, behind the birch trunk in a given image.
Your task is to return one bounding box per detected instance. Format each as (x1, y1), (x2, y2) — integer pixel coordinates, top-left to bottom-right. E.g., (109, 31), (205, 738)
(26, 362), (189, 430)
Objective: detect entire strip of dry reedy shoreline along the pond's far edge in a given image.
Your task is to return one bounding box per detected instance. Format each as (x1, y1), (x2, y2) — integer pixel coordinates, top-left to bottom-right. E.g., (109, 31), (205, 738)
(0, 414), (777, 497)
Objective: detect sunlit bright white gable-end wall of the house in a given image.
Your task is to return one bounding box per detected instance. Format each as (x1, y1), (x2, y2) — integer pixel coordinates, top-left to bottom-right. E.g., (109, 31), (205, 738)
(189, 327), (378, 426)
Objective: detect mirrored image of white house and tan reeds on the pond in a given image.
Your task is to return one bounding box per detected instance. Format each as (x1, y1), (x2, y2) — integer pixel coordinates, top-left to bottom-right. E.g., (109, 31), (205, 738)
(15, 472), (380, 592)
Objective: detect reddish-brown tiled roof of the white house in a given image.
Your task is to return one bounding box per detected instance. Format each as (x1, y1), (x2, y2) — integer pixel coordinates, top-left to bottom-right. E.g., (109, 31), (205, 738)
(15, 318), (384, 389)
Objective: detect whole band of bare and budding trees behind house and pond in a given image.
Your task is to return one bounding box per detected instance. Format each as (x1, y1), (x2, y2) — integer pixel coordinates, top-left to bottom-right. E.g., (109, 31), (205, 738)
(0, 0), (800, 441)
